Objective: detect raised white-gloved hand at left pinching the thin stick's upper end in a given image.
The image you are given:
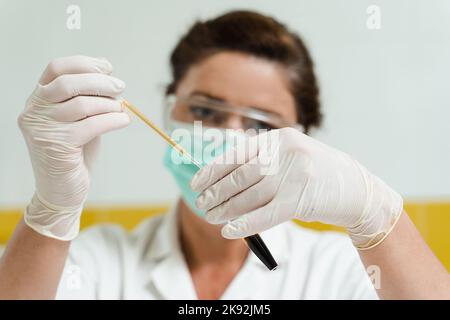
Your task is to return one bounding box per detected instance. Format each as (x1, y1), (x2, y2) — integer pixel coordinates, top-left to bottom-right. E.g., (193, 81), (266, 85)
(18, 56), (130, 240)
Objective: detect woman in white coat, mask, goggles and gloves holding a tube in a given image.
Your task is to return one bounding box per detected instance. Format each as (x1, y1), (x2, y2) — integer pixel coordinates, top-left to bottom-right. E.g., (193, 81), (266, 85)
(0, 12), (449, 299)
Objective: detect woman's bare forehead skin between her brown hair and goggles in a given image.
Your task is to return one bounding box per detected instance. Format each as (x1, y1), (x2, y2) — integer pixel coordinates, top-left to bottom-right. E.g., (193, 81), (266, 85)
(176, 51), (297, 129)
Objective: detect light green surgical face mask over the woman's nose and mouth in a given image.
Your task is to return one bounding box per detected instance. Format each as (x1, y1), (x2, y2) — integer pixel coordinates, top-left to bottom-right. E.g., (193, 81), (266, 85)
(163, 127), (244, 216)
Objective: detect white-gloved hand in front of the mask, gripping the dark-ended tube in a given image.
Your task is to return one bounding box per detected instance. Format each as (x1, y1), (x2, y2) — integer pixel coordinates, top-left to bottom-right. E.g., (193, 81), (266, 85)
(191, 128), (403, 249)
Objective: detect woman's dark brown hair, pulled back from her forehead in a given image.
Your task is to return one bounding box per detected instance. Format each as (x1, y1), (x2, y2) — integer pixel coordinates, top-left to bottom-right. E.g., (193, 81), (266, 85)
(166, 11), (322, 132)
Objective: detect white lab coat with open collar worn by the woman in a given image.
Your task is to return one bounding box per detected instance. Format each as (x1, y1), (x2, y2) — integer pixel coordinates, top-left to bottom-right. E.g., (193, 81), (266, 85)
(57, 205), (377, 299)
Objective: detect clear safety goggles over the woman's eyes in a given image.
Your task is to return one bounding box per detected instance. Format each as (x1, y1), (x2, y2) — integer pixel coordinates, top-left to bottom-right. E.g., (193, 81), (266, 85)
(164, 95), (303, 131)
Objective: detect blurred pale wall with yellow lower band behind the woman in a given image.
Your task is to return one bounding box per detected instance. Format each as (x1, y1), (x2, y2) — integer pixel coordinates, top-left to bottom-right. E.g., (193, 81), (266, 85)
(0, 0), (450, 270)
